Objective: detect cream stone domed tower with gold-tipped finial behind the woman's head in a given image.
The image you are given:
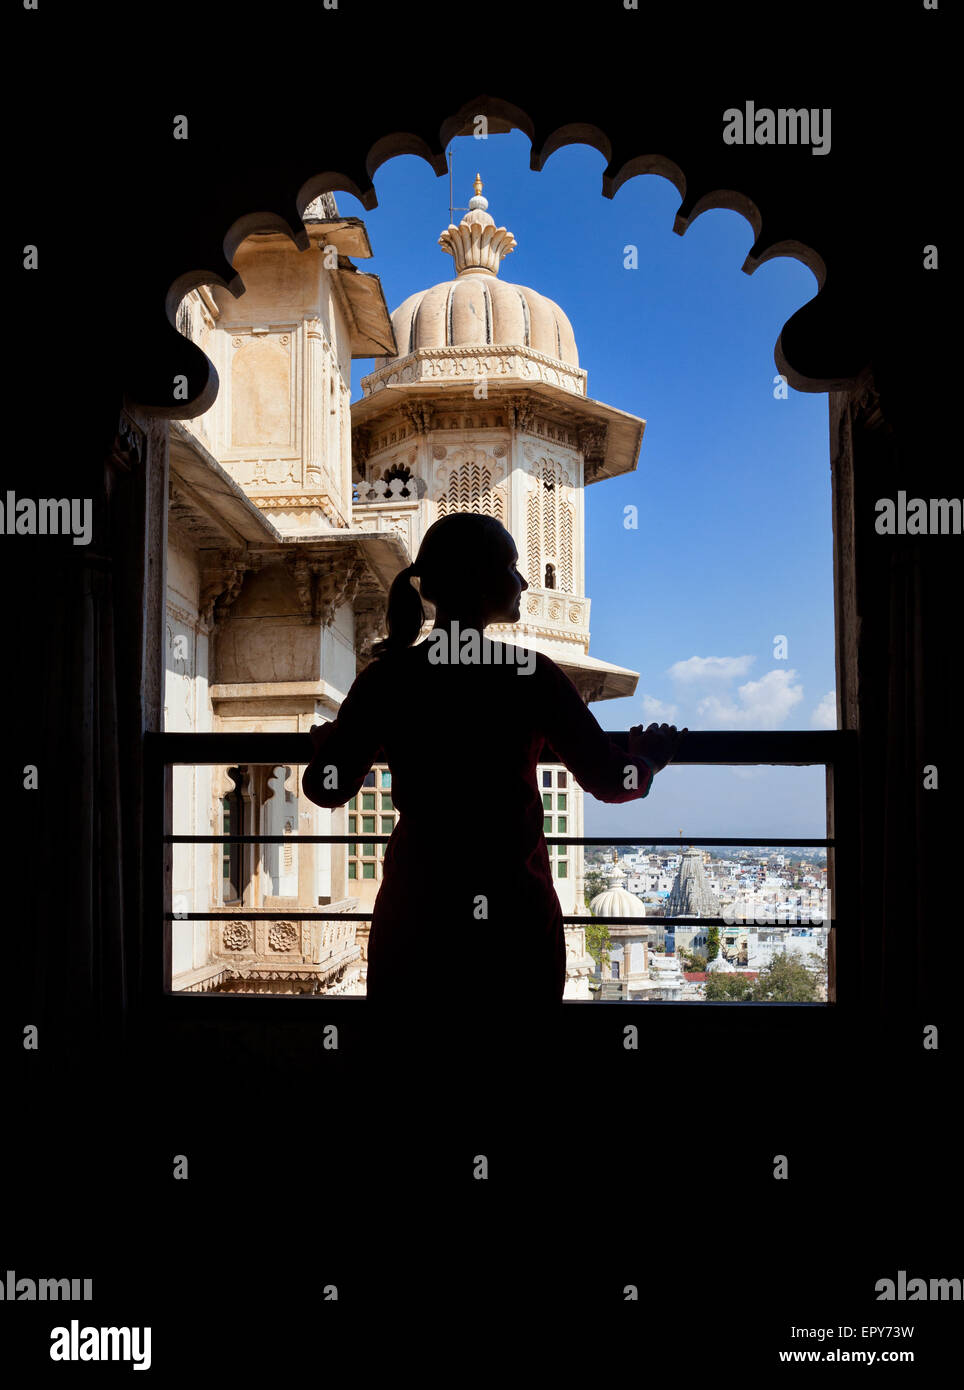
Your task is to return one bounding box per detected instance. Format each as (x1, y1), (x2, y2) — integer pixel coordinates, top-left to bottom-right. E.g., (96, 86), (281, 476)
(351, 174), (646, 700)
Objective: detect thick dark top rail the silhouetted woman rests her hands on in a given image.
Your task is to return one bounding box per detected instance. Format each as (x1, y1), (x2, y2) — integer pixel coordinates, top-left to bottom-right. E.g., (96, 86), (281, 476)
(144, 728), (857, 767)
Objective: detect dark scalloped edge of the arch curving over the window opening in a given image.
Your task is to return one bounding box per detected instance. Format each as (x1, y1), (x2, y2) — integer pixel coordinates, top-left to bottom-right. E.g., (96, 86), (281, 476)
(156, 95), (867, 418)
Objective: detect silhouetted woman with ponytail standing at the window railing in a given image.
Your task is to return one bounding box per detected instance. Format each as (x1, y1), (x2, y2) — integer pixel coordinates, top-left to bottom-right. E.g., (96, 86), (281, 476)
(303, 513), (679, 1039)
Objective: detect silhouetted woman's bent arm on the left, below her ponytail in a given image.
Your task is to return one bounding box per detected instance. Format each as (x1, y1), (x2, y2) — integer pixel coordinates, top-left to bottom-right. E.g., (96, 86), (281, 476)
(301, 662), (381, 808)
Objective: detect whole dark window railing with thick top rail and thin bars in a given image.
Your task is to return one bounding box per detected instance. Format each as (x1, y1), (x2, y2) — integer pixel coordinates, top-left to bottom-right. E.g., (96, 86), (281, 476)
(144, 730), (857, 1004)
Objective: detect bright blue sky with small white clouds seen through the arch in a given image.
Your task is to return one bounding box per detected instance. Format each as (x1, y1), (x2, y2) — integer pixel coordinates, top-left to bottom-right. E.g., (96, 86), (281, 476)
(336, 131), (836, 837)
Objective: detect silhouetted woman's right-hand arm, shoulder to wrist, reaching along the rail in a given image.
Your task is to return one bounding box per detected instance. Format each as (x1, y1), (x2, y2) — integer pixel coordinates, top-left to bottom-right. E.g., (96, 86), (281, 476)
(536, 652), (663, 803)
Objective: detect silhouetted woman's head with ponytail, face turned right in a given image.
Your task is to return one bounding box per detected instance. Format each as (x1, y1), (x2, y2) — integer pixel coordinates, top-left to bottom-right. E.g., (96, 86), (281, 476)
(374, 512), (529, 656)
